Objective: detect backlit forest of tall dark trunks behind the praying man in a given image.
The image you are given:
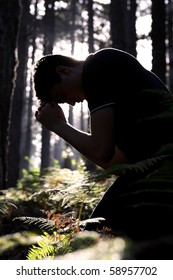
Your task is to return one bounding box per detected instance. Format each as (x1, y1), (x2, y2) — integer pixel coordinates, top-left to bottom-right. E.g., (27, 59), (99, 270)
(0, 0), (173, 189)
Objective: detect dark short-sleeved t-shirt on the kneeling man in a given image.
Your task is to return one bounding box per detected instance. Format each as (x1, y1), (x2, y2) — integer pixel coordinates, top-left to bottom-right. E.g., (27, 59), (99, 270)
(82, 49), (173, 162)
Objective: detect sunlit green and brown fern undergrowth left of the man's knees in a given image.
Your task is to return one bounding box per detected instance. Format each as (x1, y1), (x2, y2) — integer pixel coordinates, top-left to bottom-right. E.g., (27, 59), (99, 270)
(0, 167), (113, 260)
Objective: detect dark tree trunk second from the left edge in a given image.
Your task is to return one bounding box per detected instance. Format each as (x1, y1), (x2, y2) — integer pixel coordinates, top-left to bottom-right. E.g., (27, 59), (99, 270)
(7, 0), (30, 187)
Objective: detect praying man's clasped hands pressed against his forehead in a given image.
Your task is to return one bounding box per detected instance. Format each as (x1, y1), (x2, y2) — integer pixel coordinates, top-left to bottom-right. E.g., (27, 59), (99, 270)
(35, 102), (67, 131)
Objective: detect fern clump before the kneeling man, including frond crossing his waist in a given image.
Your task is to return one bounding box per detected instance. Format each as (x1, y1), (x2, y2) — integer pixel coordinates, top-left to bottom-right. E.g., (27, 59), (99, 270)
(8, 153), (171, 260)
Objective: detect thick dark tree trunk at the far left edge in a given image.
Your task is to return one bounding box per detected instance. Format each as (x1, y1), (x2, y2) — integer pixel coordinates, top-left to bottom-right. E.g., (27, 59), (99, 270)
(0, 0), (21, 188)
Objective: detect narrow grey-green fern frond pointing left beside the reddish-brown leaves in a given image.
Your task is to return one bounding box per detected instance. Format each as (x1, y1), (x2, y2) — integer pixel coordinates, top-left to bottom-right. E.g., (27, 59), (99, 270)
(13, 217), (55, 230)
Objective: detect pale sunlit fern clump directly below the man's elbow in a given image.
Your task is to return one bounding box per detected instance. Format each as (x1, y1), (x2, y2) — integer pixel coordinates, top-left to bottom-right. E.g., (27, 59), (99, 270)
(26, 167), (110, 218)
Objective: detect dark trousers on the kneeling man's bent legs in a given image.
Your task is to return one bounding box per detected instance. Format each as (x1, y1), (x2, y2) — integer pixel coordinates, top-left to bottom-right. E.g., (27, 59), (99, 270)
(85, 159), (173, 240)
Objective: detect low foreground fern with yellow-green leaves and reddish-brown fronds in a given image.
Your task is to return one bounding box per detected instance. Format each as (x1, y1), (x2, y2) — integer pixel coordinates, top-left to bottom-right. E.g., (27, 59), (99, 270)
(15, 211), (105, 260)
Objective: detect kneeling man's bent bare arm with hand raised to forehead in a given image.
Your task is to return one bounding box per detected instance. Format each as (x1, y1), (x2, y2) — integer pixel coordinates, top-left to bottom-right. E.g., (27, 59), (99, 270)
(36, 103), (127, 168)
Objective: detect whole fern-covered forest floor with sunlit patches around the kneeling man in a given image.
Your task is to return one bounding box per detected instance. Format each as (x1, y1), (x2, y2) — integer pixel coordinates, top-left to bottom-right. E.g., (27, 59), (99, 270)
(0, 164), (173, 260)
